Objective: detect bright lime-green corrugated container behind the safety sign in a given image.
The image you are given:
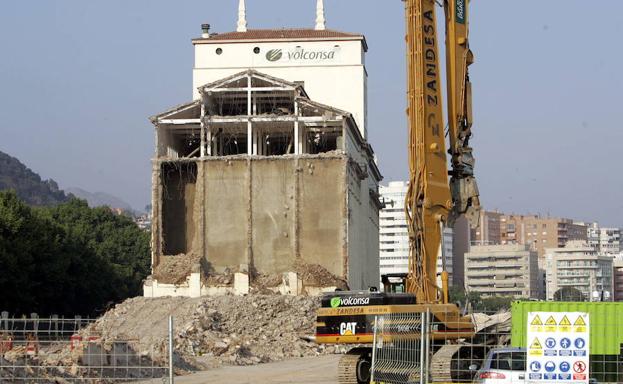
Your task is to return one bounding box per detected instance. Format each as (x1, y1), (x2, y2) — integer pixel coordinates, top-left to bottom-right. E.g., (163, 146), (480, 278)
(511, 301), (623, 355)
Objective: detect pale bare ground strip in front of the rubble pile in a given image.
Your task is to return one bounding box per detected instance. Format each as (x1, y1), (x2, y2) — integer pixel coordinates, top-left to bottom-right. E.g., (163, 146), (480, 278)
(142, 355), (341, 384)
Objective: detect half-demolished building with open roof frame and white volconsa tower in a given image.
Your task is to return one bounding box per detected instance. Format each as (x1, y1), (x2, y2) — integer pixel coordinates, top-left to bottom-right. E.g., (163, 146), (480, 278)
(144, 1), (381, 296)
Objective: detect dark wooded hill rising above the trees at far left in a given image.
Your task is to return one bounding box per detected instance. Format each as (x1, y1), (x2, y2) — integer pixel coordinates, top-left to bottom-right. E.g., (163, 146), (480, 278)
(0, 151), (69, 206)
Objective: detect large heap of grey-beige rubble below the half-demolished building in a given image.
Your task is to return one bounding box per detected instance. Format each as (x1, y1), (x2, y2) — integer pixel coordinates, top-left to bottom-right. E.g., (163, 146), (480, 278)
(89, 294), (342, 369)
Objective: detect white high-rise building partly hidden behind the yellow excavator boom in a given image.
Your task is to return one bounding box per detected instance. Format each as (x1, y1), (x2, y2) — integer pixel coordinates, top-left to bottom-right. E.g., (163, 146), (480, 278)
(379, 181), (452, 284)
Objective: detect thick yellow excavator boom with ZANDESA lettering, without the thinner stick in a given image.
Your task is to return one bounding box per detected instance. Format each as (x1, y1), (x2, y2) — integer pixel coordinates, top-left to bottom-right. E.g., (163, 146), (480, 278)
(405, 0), (452, 303)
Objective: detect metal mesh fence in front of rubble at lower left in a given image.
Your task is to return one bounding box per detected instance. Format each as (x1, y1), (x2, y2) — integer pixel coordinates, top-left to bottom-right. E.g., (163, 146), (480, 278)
(0, 314), (174, 383)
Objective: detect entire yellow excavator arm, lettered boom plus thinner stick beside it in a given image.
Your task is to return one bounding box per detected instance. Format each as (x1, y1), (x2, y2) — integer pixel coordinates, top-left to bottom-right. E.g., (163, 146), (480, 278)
(405, 0), (480, 303)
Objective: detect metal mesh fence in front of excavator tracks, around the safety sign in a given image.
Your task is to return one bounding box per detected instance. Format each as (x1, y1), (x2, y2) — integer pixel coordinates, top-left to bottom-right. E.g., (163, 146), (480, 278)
(371, 310), (623, 384)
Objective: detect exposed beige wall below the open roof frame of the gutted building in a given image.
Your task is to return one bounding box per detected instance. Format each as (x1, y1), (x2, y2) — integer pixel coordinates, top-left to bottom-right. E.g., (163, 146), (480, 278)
(152, 154), (361, 281)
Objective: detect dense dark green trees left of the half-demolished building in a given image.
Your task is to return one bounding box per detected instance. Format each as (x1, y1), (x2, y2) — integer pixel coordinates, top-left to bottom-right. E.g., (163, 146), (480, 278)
(0, 191), (150, 316)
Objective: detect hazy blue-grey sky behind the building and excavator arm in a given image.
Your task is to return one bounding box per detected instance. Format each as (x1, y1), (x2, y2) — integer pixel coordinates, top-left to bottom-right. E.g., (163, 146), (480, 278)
(0, 0), (623, 226)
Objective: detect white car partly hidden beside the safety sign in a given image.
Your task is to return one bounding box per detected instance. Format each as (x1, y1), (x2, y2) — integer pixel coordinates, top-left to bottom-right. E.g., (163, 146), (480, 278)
(470, 348), (526, 384)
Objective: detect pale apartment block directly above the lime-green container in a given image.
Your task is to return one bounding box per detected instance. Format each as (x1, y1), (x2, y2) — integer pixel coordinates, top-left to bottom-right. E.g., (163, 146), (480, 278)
(545, 241), (614, 301)
